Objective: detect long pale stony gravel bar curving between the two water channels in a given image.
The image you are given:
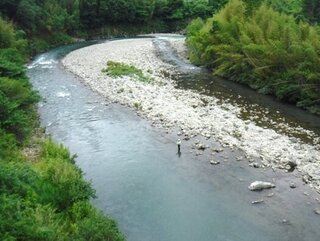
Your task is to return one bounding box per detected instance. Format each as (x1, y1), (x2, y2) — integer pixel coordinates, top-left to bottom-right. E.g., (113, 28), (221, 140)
(62, 36), (320, 192)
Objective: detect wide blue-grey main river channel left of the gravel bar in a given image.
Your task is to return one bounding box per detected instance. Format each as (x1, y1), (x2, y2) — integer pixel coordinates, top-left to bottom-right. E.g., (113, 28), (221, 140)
(28, 38), (320, 241)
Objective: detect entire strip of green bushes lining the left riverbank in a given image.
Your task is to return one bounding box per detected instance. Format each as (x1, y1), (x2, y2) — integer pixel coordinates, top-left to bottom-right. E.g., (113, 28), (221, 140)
(0, 19), (125, 241)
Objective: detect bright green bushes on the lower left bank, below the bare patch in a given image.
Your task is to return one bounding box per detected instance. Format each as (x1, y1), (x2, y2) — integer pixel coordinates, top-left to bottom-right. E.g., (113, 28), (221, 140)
(0, 140), (124, 241)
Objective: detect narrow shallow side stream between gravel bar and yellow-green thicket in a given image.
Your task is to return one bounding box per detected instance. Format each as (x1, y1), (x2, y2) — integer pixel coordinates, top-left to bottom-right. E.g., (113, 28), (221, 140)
(154, 37), (320, 144)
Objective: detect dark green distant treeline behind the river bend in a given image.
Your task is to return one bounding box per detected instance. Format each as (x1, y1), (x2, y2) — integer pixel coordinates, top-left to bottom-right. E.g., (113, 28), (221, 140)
(0, 0), (227, 53)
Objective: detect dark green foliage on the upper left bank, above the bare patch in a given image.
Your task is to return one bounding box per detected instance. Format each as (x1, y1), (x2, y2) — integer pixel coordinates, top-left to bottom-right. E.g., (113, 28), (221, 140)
(0, 18), (38, 152)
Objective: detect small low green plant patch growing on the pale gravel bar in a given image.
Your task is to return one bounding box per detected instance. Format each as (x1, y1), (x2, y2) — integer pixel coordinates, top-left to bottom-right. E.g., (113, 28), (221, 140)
(102, 61), (151, 83)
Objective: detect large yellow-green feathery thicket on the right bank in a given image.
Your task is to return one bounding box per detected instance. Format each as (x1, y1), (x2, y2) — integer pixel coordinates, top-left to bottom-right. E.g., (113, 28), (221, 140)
(187, 0), (320, 114)
